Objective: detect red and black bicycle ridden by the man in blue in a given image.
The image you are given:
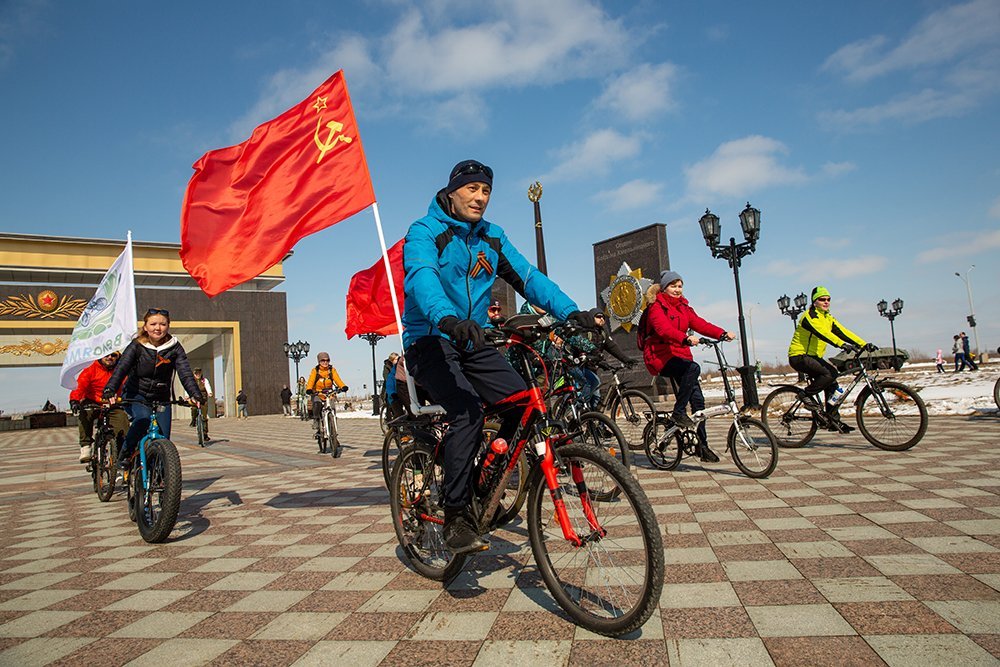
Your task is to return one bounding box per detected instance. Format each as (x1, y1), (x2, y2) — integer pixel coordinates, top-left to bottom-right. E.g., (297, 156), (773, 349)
(389, 315), (664, 637)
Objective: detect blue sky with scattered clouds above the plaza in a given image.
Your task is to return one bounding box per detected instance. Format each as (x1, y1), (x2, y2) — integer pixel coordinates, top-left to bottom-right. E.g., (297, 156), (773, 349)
(0, 0), (1000, 406)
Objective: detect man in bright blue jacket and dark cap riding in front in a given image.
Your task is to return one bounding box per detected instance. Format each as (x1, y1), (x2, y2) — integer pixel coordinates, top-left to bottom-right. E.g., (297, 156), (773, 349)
(403, 160), (594, 553)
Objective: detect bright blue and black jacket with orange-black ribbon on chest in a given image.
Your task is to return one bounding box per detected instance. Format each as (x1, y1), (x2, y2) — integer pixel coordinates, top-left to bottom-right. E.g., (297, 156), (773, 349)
(403, 190), (578, 347)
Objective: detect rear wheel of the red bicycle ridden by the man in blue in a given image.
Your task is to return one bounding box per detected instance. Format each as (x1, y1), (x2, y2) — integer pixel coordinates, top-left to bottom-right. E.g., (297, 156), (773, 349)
(389, 443), (466, 581)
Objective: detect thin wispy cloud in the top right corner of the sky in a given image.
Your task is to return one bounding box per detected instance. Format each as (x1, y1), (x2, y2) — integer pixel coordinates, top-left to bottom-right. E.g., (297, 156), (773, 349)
(823, 0), (1000, 81)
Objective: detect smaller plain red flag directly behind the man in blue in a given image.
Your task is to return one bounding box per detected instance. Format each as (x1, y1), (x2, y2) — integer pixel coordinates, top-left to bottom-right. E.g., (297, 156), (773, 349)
(344, 239), (405, 340)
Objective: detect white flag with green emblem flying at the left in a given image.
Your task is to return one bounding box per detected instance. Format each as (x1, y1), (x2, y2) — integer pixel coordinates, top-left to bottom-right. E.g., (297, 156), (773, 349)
(59, 232), (138, 389)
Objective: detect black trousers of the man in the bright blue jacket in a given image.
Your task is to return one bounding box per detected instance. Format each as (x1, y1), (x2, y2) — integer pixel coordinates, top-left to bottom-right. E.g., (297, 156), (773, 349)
(406, 336), (527, 508)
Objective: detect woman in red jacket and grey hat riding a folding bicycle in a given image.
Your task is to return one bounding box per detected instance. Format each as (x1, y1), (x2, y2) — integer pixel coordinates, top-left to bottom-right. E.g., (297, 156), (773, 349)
(642, 271), (735, 463)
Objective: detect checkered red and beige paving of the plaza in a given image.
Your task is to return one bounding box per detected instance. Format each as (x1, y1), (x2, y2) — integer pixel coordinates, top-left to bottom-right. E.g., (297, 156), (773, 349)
(0, 416), (1000, 667)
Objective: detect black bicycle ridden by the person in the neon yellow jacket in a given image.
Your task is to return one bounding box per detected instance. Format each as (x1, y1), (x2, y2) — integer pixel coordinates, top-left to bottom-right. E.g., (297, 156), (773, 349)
(761, 348), (928, 452)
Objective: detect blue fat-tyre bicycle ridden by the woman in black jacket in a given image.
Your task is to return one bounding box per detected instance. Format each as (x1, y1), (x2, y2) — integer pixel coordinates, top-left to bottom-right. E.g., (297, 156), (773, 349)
(121, 398), (190, 543)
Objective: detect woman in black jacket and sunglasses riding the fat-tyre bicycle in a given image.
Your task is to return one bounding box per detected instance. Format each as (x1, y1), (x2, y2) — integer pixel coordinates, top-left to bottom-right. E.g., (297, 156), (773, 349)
(104, 308), (205, 467)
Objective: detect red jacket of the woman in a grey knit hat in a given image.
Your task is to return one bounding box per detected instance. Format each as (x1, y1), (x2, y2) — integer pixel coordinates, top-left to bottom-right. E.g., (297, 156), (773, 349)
(642, 292), (726, 375)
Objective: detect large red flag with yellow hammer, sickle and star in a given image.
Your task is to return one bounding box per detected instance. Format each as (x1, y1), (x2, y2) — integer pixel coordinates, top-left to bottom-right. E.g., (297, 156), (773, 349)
(181, 70), (375, 296)
